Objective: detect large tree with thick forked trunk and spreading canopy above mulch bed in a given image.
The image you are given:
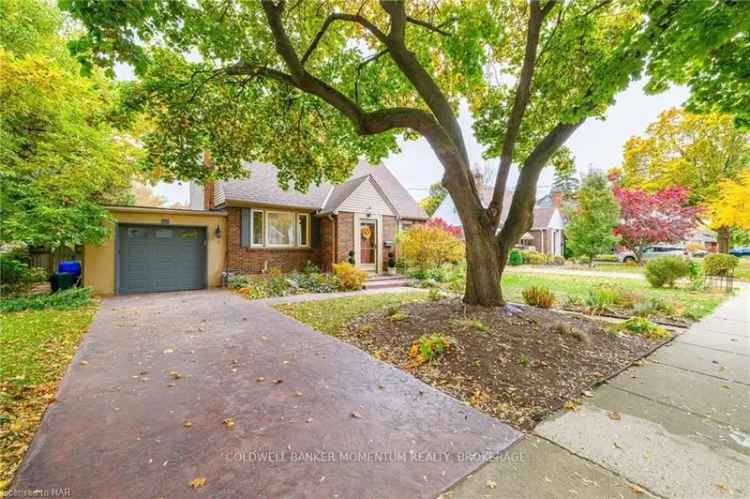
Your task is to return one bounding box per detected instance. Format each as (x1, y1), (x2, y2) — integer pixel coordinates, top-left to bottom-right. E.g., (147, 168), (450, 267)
(61, 0), (746, 305)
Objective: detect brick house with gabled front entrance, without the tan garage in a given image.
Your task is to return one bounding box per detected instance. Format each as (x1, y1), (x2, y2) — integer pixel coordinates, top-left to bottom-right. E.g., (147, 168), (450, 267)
(190, 161), (428, 273)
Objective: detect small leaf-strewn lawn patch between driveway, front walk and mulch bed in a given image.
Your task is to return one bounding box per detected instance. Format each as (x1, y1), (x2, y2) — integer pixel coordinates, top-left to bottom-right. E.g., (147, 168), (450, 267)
(274, 291), (427, 335)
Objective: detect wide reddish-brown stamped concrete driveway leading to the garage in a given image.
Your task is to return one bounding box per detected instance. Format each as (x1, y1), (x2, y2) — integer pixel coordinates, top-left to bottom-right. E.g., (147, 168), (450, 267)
(12, 291), (520, 499)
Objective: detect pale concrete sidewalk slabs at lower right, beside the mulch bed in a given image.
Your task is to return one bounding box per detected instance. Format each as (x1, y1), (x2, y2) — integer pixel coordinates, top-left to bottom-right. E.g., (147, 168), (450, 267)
(445, 289), (750, 499)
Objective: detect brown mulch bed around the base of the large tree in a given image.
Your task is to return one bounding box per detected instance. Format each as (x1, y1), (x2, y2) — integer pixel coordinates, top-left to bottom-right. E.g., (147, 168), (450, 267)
(336, 299), (665, 430)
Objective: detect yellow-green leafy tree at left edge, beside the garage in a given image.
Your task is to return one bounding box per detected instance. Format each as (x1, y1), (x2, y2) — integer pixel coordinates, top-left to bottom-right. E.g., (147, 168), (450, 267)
(0, 0), (138, 247)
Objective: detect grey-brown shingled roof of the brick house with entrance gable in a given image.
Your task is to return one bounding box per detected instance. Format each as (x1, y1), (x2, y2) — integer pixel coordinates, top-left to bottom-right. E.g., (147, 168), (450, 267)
(214, 161), (429, 220)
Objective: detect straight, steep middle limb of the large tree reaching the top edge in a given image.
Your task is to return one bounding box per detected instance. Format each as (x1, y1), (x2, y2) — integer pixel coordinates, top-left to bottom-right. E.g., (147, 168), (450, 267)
(487, 0), (554, 227)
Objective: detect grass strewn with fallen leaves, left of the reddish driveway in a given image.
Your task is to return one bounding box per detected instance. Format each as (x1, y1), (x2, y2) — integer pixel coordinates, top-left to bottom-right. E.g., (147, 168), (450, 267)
(0, 305), (96, 492)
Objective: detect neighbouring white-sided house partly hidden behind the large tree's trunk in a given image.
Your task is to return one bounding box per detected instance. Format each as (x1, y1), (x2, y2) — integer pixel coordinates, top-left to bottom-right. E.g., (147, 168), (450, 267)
(433, 189), (565, 256)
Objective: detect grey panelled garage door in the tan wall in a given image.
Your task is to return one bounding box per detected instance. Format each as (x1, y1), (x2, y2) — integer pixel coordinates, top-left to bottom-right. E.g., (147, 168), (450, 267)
(118, 225), (206, 293)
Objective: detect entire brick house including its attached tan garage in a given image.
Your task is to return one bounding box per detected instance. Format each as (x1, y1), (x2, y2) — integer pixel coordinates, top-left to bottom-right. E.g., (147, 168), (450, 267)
(84, 162), (428, 294)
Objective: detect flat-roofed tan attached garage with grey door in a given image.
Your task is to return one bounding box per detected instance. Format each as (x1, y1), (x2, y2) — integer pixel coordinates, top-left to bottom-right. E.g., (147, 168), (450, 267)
(83, 206), (226, 295)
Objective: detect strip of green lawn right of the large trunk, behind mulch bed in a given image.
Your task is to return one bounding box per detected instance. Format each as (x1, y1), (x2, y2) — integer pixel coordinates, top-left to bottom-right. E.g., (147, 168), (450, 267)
(502, 269), (728, 318)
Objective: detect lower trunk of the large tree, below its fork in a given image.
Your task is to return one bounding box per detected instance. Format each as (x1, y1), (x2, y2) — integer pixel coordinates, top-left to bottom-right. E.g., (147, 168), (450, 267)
(464, 229), (505, 307)
